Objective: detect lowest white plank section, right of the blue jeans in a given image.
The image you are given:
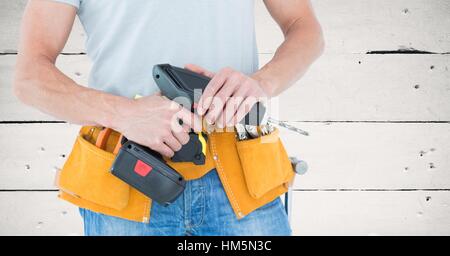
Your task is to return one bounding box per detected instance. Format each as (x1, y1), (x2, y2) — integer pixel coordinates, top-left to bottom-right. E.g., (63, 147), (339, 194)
(292, 191), (450, 236)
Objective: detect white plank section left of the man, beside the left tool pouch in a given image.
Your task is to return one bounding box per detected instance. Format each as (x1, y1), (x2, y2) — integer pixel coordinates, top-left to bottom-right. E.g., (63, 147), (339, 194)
(0, 124), (78, 189)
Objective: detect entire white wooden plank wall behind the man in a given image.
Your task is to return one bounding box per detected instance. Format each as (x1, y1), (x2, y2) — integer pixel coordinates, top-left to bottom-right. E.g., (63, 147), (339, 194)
(0, 0), (450, 235)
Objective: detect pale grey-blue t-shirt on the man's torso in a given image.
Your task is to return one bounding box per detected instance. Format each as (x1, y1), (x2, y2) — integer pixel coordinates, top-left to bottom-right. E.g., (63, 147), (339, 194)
(55, 0), (258, 98)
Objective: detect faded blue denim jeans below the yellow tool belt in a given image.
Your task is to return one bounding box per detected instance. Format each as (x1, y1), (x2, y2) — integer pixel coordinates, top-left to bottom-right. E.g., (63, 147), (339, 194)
(80, 170), (291, 236)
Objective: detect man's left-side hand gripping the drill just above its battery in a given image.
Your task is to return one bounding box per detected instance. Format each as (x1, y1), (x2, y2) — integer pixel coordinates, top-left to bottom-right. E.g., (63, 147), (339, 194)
(112, 93), (201, 157)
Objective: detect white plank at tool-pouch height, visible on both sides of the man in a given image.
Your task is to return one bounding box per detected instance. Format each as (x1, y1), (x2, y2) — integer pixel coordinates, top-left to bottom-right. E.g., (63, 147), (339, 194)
(0, 123), (450, 189)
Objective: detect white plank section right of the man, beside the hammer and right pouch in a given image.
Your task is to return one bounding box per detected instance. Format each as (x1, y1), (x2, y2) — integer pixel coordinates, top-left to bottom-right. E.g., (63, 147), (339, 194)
(282, 123), (450, 189)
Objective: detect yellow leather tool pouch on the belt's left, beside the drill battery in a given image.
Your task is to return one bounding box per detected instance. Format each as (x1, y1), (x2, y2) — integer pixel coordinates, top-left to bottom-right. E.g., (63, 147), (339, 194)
(57, 127), (130, 210)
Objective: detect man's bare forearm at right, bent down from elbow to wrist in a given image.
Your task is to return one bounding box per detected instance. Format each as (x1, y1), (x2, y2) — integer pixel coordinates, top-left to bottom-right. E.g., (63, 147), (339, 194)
(253, 16), (324, 97)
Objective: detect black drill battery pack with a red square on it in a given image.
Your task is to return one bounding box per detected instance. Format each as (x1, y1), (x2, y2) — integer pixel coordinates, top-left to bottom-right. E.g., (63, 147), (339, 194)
(111, 141), (186, 206)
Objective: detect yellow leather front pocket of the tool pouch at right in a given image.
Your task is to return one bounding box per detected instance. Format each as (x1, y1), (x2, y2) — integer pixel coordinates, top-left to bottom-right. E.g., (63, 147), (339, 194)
(236, 130), (293, 199)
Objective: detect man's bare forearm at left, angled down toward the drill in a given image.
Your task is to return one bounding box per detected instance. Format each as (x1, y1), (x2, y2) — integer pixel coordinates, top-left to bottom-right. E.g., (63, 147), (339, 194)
(14, 55), (129, 127)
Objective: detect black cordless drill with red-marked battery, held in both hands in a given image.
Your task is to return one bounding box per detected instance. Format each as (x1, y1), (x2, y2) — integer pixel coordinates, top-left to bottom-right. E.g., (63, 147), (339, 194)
(111, 64), (260, 205)
